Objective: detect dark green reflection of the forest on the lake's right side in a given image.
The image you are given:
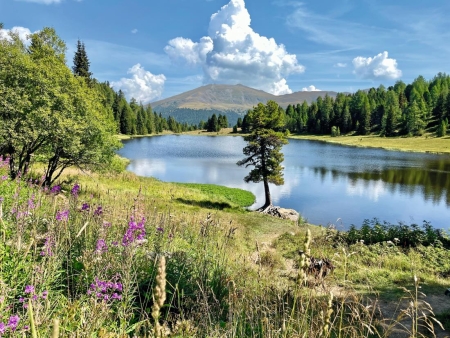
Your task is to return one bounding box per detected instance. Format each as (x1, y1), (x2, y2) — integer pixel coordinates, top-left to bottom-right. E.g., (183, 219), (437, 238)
(312, 158), (450, 206)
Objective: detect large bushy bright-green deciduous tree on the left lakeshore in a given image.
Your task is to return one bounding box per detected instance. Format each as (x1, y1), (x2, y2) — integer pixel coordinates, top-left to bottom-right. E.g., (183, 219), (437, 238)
(0, 28), (120, 185)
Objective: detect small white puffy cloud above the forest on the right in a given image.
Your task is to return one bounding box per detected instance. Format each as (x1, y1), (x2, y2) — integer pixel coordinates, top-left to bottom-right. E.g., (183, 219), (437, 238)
(352, 51), (402, 79)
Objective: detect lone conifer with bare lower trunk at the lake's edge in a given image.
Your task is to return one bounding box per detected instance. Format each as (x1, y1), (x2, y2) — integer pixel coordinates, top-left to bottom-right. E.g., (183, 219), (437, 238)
(237, 101), (287, 211)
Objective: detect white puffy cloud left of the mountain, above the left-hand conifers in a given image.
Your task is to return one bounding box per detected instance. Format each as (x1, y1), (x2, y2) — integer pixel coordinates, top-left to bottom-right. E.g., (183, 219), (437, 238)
(111, 63), (166, 103)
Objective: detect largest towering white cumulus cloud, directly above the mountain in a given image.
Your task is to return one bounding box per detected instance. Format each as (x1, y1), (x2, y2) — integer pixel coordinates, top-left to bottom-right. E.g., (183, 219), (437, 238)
(164, 0), (305, 95)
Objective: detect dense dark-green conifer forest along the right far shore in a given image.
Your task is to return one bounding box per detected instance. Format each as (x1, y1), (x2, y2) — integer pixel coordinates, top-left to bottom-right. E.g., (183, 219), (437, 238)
(248, 73), (450, 137)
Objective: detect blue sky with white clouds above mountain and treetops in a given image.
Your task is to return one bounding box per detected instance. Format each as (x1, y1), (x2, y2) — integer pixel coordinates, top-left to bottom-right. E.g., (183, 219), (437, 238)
(0, 0), (450, 103)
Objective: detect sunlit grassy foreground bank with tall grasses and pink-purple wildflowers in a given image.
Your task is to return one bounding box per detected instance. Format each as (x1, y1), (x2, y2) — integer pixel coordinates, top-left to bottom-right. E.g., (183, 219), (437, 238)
(0, 157), (450, 338)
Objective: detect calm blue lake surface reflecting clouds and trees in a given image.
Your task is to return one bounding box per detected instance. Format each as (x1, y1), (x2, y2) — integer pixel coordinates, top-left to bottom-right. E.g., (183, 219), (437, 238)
(119, 135), (450, 229)
